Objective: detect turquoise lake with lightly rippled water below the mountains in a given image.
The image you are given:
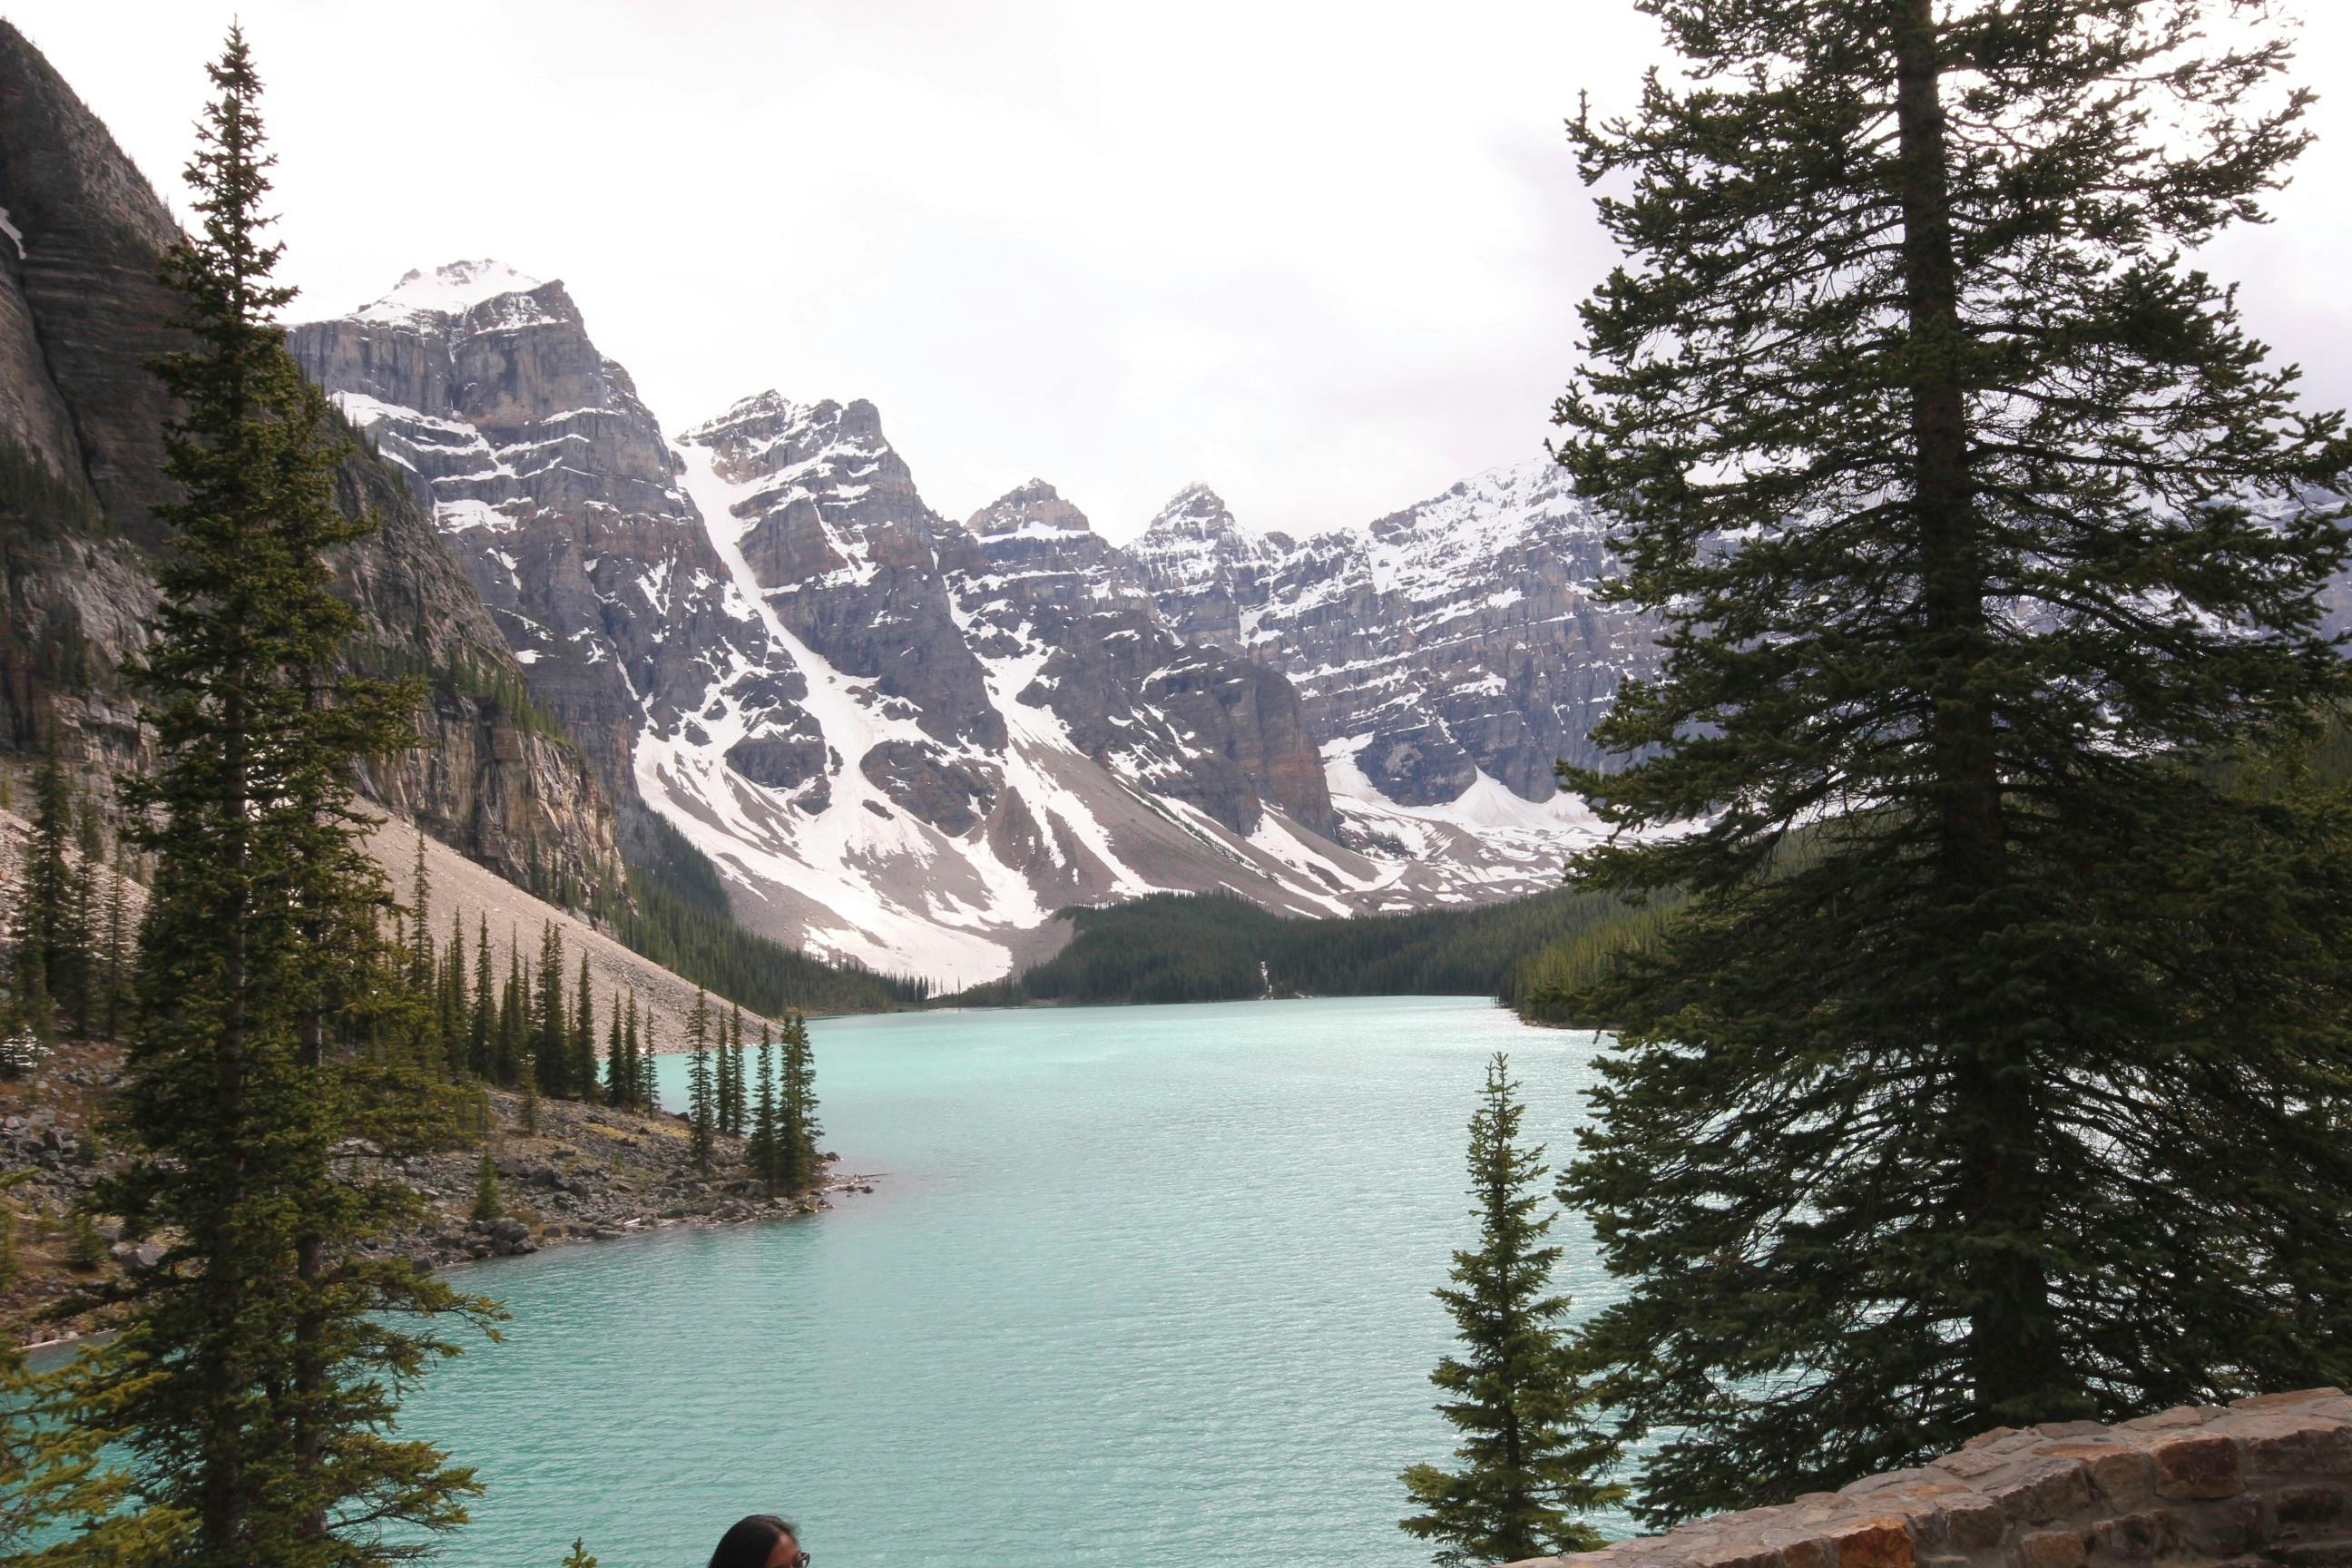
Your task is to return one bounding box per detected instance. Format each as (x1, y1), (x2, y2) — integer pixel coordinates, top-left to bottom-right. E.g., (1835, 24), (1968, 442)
(284, 996), (1622, 1568)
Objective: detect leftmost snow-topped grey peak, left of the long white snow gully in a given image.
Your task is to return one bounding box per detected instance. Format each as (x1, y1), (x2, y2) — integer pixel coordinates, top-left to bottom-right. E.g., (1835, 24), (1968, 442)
(287, 261), (761, 801)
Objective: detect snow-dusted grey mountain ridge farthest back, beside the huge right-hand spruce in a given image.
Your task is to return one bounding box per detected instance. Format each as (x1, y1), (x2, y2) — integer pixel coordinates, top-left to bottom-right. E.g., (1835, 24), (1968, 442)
(1133, 461), (1656, 807)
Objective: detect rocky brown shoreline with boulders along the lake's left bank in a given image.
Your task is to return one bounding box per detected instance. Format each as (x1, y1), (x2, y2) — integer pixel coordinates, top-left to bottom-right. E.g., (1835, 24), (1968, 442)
(0, 1044), (875, 1345)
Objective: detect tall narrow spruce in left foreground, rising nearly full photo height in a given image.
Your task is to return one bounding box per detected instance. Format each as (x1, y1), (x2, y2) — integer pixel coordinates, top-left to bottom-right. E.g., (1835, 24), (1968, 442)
(59, 28), (489, 1568)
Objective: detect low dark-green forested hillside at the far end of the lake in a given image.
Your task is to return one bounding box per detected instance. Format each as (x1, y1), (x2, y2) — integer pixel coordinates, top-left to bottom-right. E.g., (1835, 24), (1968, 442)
(953, 888), (1642, 1006)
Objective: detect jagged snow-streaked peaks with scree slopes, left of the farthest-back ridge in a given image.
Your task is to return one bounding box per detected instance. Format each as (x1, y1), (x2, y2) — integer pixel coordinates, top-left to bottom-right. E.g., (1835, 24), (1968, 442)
(289, 261), (1618, 985)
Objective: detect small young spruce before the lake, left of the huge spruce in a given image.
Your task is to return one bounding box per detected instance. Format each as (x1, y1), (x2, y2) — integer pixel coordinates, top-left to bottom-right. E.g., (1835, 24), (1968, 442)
(1402, 1051), (1622, 1568)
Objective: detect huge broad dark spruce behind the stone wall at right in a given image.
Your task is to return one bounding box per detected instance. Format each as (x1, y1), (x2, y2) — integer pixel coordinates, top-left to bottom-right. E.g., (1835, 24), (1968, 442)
(1557, 0), (2352, 1524)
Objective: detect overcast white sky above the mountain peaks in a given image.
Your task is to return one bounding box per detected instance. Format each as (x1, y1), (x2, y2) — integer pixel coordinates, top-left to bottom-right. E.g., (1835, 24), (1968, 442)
(14, 0), (2352, 538)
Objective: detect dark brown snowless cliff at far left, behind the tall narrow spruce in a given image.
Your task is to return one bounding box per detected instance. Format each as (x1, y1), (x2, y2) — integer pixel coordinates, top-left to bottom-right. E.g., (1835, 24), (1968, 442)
(0, 24), (619, 902)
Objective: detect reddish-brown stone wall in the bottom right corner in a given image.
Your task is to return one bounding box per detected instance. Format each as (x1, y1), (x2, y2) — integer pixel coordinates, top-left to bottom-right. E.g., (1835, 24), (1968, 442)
(1514, 1389), (2352, 1568)
